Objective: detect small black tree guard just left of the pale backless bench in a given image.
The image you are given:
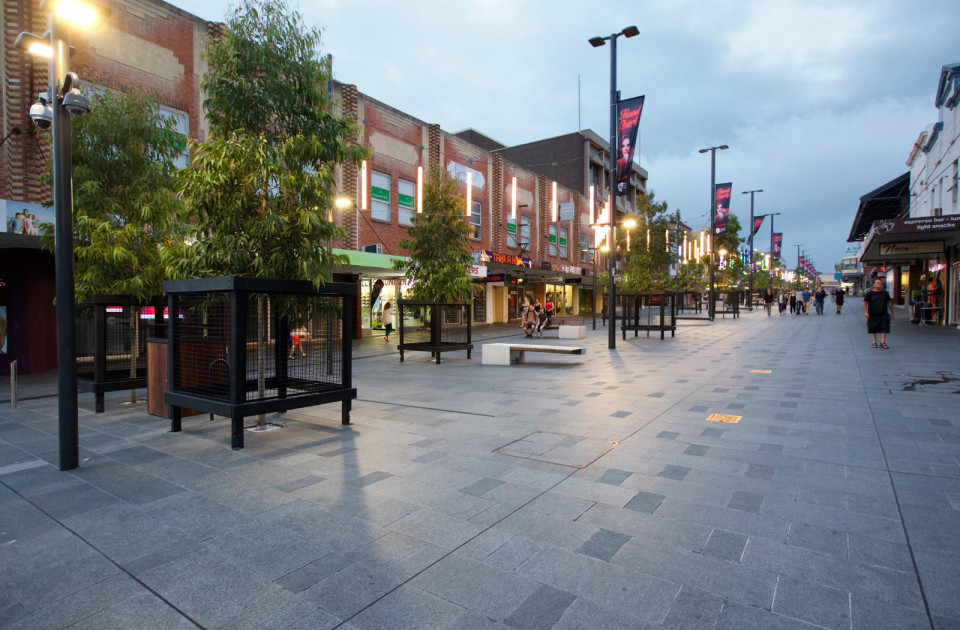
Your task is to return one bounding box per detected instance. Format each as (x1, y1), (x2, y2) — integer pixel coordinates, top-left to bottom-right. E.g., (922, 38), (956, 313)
(397, 300), (473, 363)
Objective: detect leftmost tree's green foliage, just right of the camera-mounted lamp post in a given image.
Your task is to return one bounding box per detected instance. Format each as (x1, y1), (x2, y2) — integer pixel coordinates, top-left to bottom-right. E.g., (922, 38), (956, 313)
(43, 91), (186, 300)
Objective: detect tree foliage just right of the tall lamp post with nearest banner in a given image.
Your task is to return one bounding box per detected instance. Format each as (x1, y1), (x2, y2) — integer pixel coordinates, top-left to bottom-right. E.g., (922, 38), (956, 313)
(617, 192), (680, 291)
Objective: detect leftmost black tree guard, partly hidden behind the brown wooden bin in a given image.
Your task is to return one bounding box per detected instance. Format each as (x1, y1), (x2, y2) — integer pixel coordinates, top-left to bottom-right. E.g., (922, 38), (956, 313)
(76, 295), (164, 413)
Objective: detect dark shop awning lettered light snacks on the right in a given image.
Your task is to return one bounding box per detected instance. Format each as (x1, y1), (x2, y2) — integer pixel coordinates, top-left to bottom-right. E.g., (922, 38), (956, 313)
(860, 214), (960, 265)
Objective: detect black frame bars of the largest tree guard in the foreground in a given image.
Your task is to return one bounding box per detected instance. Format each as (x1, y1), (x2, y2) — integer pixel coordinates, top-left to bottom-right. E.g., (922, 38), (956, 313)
(163, 276), (357, 449)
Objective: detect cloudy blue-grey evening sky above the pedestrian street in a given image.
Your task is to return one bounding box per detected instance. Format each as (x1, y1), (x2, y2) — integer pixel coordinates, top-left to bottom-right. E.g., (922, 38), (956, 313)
(172, 0), (960, 272)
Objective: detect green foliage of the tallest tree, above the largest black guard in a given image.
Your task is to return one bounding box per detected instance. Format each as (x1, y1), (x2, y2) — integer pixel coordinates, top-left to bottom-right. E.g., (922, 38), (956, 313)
(171, 0), (365, 286)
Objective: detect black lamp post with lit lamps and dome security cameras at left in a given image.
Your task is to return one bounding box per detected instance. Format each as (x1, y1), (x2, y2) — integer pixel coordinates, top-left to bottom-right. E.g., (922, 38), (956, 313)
(16, 0), (109, 470)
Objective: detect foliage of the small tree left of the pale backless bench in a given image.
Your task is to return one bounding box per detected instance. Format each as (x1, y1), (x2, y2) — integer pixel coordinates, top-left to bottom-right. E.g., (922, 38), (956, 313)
(398, 170), (473, 301)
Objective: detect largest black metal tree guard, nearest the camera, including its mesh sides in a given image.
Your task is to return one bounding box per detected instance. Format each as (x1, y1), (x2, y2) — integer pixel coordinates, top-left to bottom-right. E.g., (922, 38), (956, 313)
(163, 276), (357, 449)
